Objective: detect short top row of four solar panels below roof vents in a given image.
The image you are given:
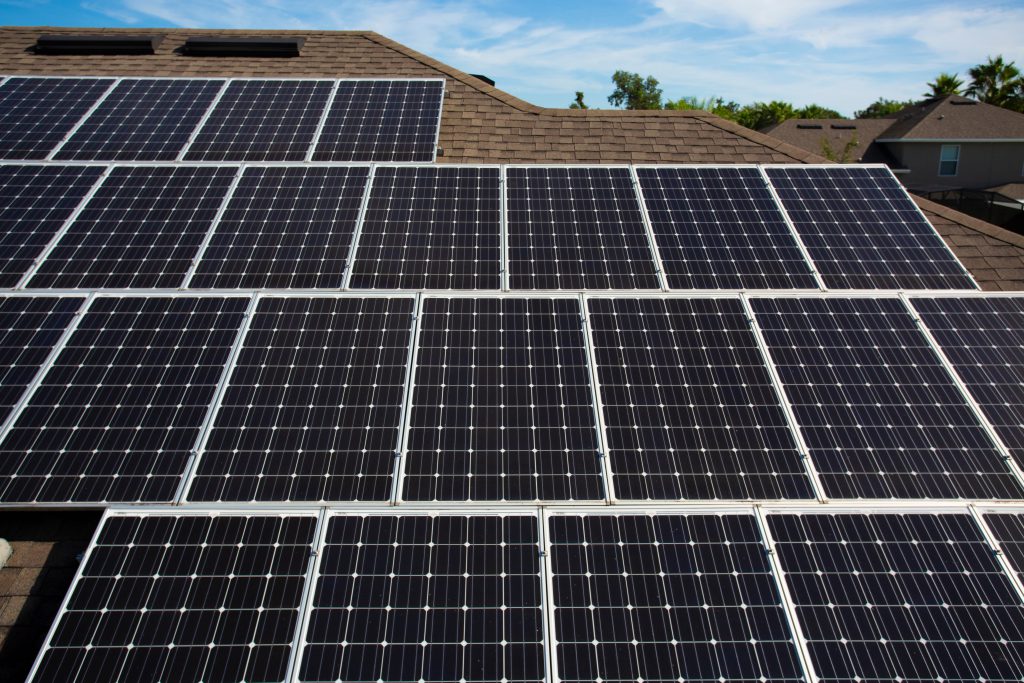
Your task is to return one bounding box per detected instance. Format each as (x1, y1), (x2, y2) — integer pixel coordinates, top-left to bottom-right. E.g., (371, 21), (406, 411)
(0, 77), (444, 162)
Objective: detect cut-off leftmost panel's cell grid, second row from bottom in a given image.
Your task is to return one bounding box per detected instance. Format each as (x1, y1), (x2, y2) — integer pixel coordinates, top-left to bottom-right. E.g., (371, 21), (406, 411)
(0, 297), (83, 424)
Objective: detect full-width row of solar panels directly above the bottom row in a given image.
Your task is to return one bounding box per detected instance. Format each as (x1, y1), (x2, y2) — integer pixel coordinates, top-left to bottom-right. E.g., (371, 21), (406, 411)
(0, 295), (1024, 503)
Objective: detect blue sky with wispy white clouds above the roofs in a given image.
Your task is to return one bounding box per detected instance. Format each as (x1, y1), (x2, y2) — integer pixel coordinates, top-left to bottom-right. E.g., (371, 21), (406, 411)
(0, 0), (1024, 115)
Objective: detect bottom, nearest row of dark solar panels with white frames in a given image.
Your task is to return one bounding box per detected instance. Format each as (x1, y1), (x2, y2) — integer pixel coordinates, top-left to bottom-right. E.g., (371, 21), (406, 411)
(24, 508), (1024, 683)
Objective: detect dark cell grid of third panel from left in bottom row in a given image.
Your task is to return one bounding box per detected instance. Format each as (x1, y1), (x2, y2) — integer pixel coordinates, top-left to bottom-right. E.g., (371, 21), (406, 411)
(550, 514), (806, 683)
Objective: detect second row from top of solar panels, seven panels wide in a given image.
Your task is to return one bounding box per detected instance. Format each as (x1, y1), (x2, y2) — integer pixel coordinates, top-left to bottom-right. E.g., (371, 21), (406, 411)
(0, 165), (976, 290)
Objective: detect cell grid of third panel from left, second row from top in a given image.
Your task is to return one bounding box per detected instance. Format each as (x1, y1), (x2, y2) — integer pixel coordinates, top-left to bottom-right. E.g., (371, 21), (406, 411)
(189, 167), (370, 289)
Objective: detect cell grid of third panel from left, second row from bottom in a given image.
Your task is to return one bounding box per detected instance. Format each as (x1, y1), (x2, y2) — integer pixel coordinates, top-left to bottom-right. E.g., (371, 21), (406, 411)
(188, 297), (414, 501)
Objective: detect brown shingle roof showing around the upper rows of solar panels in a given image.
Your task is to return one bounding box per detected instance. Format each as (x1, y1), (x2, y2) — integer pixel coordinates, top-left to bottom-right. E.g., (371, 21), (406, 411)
(0, 27), (1024, 290)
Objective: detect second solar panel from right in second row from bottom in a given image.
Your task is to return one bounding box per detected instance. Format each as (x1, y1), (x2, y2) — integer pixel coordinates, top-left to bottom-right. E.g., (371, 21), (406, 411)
(752, 298), (1024, 499)
